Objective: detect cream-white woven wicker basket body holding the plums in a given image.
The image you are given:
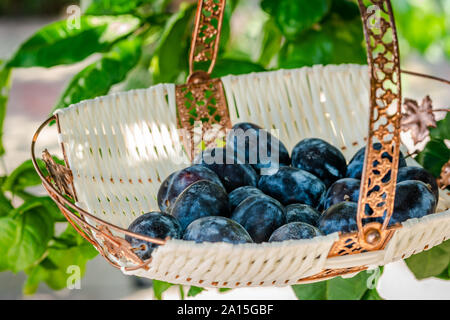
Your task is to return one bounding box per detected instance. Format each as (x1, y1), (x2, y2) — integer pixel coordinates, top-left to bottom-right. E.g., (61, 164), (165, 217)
(32, 1), (450, 288)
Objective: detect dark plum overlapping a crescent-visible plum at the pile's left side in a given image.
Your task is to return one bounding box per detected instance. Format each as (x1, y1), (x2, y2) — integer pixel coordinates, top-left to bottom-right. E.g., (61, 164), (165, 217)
(171, 180), (230, 230)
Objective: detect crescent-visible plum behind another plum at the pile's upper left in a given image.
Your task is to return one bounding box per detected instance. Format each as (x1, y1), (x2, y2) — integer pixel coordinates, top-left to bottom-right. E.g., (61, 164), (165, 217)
(157, 165), (223, 213)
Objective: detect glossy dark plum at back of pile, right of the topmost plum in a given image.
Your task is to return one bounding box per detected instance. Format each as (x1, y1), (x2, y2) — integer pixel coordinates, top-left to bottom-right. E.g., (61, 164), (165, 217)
(291, 138), (347, 188)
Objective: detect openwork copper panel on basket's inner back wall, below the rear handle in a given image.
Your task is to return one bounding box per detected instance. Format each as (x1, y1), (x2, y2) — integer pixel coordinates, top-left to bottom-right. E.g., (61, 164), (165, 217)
(176, 79), (231, 160)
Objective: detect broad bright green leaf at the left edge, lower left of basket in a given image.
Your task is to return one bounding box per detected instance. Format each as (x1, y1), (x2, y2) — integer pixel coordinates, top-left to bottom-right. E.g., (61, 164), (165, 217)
(0, 207), (54, 272)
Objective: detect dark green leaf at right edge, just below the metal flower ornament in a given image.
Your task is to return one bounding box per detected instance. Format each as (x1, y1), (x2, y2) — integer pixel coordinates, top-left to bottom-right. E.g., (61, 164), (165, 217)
(415, 138), (450, 177)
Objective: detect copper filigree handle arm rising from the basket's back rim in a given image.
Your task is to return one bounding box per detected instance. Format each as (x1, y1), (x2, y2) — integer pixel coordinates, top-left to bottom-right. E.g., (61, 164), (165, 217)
(189, 0), (225, 74)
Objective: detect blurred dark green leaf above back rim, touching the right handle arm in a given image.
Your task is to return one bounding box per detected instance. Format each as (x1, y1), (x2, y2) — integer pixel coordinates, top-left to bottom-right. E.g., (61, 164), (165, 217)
(278, 15), (366, 68)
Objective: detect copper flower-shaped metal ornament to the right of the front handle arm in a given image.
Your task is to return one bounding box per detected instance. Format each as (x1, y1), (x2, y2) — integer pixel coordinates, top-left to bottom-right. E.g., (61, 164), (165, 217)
(401, 95), (436, 144)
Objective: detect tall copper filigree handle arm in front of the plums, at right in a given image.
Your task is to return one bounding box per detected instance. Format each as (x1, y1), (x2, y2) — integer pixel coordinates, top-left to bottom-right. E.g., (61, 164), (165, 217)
(357, 0), (401, 243)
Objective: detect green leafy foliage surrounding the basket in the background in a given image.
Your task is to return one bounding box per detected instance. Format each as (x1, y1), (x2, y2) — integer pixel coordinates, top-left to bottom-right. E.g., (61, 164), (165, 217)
(0, 0), (450, 300)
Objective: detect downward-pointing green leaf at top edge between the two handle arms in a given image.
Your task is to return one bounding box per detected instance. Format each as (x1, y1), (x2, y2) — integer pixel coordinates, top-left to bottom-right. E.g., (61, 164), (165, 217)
(261, 0), (331, 39)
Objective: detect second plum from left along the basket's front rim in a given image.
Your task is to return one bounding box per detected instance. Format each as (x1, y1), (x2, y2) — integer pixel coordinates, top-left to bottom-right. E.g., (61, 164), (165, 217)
(183, 217), (253, 244)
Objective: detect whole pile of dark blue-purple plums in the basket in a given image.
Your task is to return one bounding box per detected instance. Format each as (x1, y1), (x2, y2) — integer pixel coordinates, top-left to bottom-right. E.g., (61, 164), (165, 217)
(126, 123), (438, 259)
